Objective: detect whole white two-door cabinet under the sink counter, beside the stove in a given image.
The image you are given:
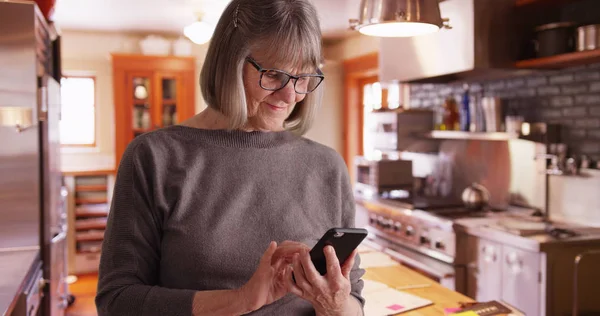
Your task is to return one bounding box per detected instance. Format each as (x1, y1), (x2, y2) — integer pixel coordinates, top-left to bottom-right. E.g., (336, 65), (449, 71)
(467, 238), (543, 315)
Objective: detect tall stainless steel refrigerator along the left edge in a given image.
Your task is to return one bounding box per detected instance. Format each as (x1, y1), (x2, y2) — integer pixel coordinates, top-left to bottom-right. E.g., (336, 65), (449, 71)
(0, 1), (68, 316)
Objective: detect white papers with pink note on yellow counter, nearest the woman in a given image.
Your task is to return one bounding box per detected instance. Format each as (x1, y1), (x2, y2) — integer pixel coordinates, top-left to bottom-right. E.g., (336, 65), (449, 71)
(363, 280), (433, 316)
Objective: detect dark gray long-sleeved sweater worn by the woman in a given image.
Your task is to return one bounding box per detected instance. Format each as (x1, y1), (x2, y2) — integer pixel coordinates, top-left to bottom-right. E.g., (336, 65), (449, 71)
(96, 126), (364, 316)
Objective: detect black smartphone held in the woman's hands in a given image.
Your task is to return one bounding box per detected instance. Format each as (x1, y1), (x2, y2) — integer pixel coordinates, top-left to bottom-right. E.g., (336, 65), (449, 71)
(310, 228), (367, 275)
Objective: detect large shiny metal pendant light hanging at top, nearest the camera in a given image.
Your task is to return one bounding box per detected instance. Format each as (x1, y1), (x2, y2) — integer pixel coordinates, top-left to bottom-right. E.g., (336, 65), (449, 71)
(350, 0), (451, 37)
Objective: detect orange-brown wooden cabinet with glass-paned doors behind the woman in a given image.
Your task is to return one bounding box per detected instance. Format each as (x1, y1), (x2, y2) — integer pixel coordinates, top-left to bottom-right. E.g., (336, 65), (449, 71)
(112, 54), (196, 165)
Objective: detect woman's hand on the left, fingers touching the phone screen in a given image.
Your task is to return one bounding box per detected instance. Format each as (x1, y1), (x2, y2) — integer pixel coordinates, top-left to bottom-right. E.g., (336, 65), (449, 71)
(239, 241), (291, 311)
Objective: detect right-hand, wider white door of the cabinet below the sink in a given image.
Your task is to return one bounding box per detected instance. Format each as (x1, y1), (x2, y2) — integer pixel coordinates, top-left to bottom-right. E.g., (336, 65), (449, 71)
(501, 246), (542, 315)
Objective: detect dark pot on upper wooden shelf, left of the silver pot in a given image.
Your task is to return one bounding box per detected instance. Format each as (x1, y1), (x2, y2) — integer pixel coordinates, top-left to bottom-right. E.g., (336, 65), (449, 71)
(535, 22), (576, 57)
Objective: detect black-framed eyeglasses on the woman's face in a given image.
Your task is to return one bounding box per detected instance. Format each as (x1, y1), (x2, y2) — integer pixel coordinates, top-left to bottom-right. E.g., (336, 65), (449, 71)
(246, 57), (325, 94)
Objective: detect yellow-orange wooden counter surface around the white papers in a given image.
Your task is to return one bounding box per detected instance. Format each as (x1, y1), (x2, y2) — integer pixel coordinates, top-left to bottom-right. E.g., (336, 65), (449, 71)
(363, 265), (473, 316)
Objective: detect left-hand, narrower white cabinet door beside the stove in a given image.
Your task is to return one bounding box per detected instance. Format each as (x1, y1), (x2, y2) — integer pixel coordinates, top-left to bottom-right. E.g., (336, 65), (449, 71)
(475, 239), (502, 302)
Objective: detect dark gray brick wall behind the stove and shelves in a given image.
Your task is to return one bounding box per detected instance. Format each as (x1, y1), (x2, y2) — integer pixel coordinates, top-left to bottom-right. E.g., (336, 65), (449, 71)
(410, 64), (600, 161)
